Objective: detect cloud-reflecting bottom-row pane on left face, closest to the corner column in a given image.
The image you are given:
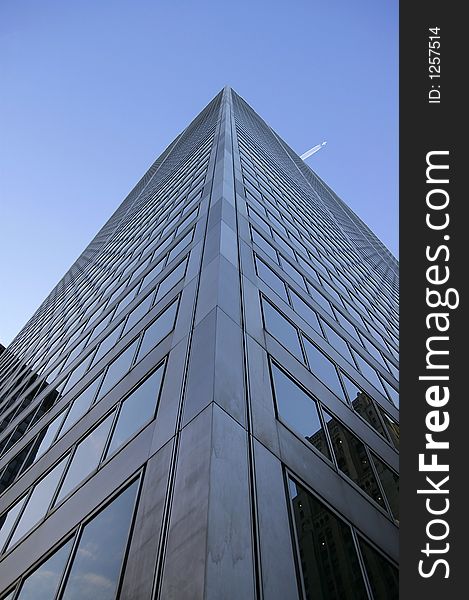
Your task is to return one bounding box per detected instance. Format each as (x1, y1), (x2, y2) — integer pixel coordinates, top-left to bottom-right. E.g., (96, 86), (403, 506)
(62, 482), (138, 600)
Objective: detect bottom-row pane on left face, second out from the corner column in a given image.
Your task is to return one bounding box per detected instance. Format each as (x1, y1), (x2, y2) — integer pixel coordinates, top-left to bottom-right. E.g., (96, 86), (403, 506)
(17, 540), (73, 600)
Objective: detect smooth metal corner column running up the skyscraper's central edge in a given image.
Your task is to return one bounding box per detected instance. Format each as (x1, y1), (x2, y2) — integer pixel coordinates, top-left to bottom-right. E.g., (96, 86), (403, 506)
(159, 88), (255, 600)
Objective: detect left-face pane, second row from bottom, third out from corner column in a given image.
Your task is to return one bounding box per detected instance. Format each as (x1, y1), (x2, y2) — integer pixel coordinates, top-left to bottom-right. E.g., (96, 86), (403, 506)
(8, 456), (68, 547)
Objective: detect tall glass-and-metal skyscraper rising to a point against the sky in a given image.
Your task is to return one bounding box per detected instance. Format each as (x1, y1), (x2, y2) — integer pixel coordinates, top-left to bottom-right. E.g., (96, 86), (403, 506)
(0, 88), (399, 600)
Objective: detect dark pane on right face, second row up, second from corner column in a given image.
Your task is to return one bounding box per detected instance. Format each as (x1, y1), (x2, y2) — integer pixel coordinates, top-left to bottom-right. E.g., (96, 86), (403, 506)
(324, 411), (385, 508)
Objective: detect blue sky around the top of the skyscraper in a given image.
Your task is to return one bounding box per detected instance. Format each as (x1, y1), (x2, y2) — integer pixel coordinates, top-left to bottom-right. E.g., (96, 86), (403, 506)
(0, 0), (398, 344)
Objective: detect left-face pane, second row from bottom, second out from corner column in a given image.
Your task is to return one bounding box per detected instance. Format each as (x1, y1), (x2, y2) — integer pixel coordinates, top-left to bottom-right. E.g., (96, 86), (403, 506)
(55, 412), (114, 503)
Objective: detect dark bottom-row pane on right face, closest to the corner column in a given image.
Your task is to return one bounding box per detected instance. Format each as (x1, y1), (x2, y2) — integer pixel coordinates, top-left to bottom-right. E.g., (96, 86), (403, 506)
(289, 480), (368, 600)
